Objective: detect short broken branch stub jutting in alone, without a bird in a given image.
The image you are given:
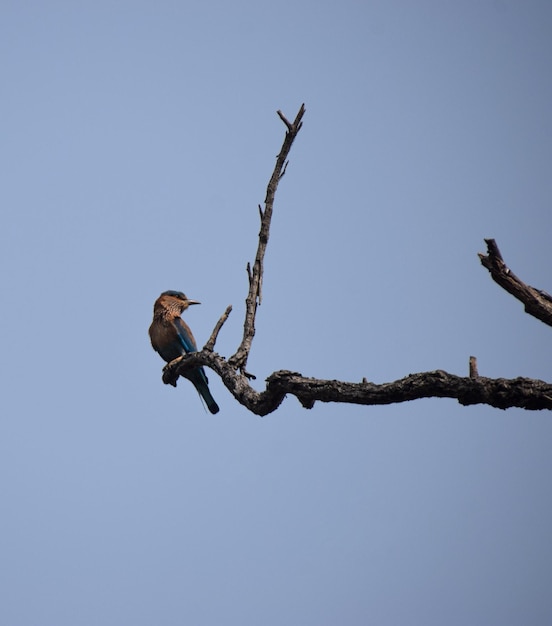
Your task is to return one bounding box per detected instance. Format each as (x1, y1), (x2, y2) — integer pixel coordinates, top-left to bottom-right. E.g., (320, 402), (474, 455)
(479, 239), (552, 326)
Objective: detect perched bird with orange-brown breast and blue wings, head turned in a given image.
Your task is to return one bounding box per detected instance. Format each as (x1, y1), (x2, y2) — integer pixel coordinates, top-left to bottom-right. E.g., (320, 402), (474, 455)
(149, 291), (219, 414)
